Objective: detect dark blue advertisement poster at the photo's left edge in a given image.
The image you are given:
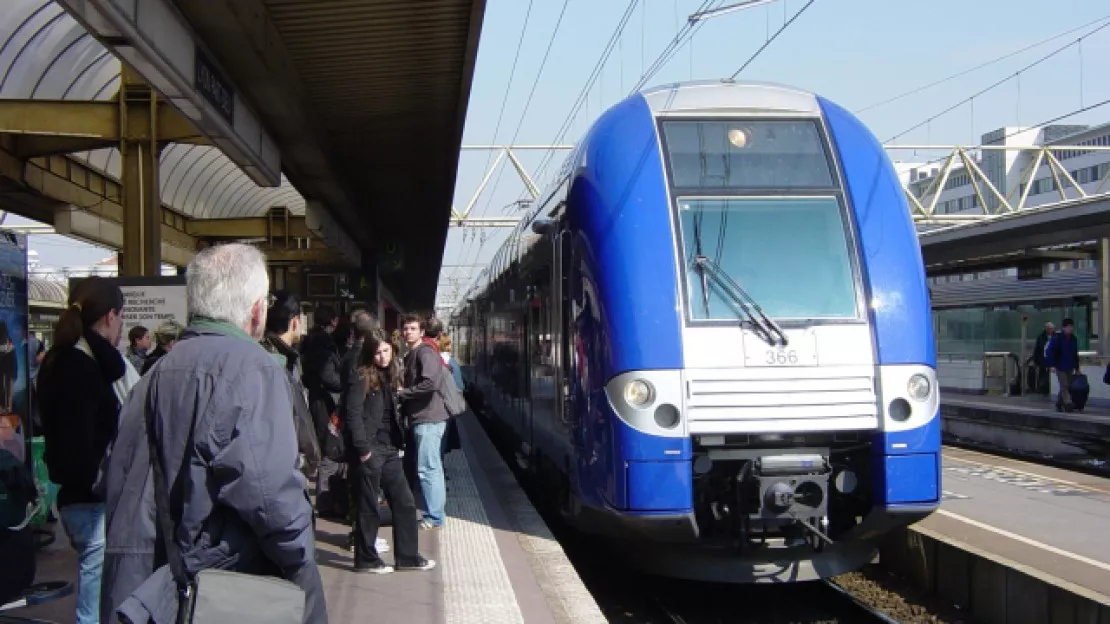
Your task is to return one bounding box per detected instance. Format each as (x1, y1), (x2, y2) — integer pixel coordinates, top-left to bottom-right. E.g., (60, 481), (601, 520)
(0, 232), (30, 460)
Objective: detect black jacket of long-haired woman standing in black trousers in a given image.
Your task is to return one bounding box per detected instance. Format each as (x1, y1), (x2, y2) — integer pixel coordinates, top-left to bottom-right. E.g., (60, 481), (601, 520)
(343, 378), (404, 459)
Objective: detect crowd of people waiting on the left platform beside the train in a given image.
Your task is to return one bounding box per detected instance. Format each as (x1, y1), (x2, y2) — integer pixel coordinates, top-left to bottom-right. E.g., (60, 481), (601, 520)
(21, 244), (462, 624)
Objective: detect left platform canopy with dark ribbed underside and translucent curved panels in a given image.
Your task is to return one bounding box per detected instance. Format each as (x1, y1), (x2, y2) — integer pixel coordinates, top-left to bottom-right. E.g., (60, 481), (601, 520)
(0, 0), (485, 308)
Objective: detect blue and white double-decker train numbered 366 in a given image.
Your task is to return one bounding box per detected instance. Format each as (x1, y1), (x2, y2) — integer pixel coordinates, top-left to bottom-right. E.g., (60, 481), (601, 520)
(451, 81), (940, 583)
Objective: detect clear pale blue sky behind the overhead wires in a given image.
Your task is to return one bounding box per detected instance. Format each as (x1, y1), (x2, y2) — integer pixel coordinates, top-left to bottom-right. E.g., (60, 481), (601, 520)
(17, 0), (1110, 296)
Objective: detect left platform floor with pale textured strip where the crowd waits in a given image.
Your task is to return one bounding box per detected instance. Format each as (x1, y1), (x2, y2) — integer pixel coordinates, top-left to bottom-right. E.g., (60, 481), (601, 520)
(0, 413), (606, 624)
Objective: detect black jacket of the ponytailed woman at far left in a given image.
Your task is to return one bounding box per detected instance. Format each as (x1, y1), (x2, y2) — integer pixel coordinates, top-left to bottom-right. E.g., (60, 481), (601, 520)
(38, 331), (124, 506)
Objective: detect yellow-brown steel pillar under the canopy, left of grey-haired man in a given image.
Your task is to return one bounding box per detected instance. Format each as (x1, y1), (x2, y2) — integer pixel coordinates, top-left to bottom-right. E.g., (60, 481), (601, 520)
(118, 63), (162, 276)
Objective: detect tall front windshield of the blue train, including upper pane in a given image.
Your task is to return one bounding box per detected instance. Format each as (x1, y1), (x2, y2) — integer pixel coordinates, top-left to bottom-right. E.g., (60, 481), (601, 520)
(663, 120), (859, 321)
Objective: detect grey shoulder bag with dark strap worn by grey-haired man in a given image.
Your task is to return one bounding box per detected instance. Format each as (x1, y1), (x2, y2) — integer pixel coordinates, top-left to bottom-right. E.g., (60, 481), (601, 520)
(143, 384), (304, 624)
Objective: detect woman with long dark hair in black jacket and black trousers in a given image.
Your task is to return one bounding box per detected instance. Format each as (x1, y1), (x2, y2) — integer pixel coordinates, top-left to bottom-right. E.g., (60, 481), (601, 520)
(344, 330), (435, 574)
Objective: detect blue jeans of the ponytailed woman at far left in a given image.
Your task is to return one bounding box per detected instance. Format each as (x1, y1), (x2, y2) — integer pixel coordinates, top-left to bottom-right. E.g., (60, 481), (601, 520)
(58, 503), (104, 624)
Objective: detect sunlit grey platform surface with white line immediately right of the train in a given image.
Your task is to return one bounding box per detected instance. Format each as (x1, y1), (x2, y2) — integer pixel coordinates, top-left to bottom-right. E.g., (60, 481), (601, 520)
(936, 447), (1110, 601)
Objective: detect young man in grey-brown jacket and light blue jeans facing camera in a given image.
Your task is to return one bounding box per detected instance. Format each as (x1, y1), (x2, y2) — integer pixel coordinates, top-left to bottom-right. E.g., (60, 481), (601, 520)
(397, 315), (450, 531)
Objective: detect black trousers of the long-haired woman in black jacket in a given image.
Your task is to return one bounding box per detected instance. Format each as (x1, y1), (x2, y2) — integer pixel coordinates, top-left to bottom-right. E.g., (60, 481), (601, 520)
(351, 450), (420, 564)
